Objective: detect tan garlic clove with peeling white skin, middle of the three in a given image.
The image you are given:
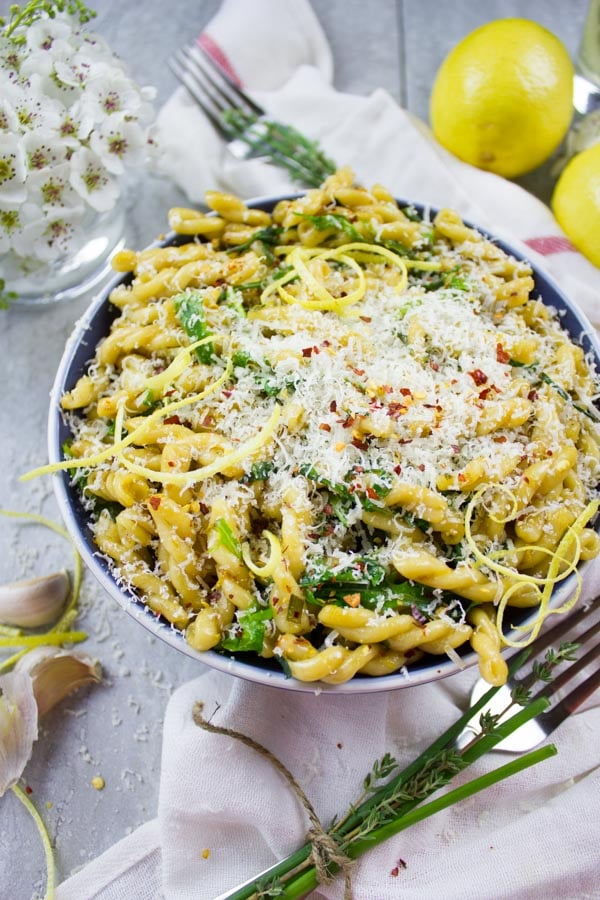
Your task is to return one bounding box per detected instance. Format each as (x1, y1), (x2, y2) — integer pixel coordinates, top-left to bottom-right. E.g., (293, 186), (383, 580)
(15, 647), (101, 716)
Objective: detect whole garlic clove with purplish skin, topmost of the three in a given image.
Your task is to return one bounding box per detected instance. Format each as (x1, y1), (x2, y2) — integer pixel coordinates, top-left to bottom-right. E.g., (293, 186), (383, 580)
(0, 569), (71, 628)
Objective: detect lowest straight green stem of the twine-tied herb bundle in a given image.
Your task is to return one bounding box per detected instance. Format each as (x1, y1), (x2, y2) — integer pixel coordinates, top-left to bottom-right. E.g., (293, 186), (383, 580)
(282, 744), (557, 900)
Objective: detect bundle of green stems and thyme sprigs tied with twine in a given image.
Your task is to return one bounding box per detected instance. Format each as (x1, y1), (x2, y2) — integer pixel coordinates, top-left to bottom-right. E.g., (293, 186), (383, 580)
(227, 643), (578, 900)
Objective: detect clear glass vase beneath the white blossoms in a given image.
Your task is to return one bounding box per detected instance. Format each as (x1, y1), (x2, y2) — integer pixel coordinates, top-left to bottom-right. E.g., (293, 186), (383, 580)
(0, 196), (125, 306)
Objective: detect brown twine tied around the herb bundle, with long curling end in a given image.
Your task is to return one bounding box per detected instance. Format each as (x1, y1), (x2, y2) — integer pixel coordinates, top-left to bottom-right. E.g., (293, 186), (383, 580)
(192, 701), (353, 900)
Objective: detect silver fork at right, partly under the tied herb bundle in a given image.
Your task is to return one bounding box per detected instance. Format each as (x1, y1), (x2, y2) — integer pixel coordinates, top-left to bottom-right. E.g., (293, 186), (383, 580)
(456, 597), (600, 753)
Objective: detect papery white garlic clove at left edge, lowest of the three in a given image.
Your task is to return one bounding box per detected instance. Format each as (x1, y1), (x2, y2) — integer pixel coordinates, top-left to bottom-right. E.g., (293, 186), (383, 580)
(0, 671), (38, 797)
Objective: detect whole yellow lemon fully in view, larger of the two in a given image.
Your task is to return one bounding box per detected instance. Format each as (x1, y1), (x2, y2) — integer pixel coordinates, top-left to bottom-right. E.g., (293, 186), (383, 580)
(430, 19), (574, 178)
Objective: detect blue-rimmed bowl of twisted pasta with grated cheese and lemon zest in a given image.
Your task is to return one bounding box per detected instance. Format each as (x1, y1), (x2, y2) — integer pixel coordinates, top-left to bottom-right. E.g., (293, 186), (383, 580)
(43, 170), (600, 693)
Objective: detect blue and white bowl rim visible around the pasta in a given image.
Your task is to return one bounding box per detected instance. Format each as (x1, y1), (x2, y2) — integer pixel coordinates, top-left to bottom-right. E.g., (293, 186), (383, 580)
(48, 193), (600, 694)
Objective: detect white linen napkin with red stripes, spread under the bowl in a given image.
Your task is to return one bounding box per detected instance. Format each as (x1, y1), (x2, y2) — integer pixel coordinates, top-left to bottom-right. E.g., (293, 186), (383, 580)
(56, 0), (600, 900)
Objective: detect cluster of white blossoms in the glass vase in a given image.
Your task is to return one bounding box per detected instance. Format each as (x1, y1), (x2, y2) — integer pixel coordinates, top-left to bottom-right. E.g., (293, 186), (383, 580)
(0, 13), (155, 265)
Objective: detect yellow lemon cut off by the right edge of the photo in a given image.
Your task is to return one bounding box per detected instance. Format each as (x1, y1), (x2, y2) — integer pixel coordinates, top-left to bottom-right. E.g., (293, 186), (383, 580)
(552, 144), (600, 268)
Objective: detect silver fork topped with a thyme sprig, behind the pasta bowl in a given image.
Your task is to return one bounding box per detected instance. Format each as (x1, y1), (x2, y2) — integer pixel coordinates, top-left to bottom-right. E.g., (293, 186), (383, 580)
(169, 43), (336, 187)
